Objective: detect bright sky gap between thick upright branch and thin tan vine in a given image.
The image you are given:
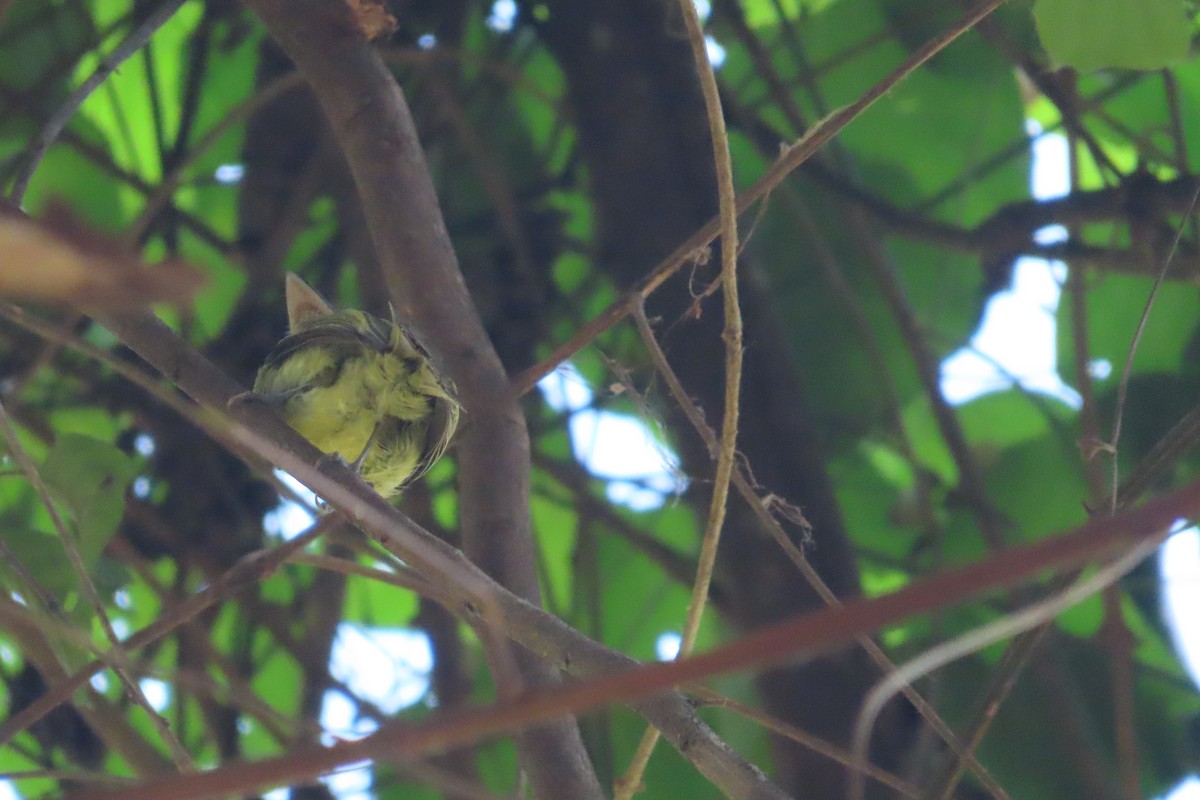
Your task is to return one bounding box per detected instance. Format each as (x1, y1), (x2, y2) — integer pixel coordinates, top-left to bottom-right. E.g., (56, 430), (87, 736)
(538, 365), (686, 511)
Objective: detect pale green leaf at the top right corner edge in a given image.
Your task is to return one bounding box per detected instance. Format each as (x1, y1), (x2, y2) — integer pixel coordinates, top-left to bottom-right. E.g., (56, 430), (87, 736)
(1033, 0), (1192, 72)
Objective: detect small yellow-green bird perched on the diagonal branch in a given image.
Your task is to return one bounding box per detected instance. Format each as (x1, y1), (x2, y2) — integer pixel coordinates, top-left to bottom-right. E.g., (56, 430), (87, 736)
(234, 273), (460, 498)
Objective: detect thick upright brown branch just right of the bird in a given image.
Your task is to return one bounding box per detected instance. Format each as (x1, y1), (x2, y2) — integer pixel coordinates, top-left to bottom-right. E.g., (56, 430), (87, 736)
(240, 0), (602, 800)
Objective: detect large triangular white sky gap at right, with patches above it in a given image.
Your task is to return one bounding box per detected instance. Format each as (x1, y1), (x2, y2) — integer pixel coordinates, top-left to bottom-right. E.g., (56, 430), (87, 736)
(942, 121), (1084, 408)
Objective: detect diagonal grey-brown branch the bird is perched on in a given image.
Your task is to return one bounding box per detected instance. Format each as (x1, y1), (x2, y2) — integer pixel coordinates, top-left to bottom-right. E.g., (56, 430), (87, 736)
(35, 303), (786, 800)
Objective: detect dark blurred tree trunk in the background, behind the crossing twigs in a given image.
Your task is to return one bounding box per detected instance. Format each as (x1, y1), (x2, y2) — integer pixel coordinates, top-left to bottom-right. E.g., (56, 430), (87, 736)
(530, 0), (910, 798)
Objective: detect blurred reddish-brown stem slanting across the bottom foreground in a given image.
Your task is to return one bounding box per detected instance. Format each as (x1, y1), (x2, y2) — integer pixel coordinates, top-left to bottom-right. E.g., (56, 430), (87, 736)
(70, 482), (1200, 800)
